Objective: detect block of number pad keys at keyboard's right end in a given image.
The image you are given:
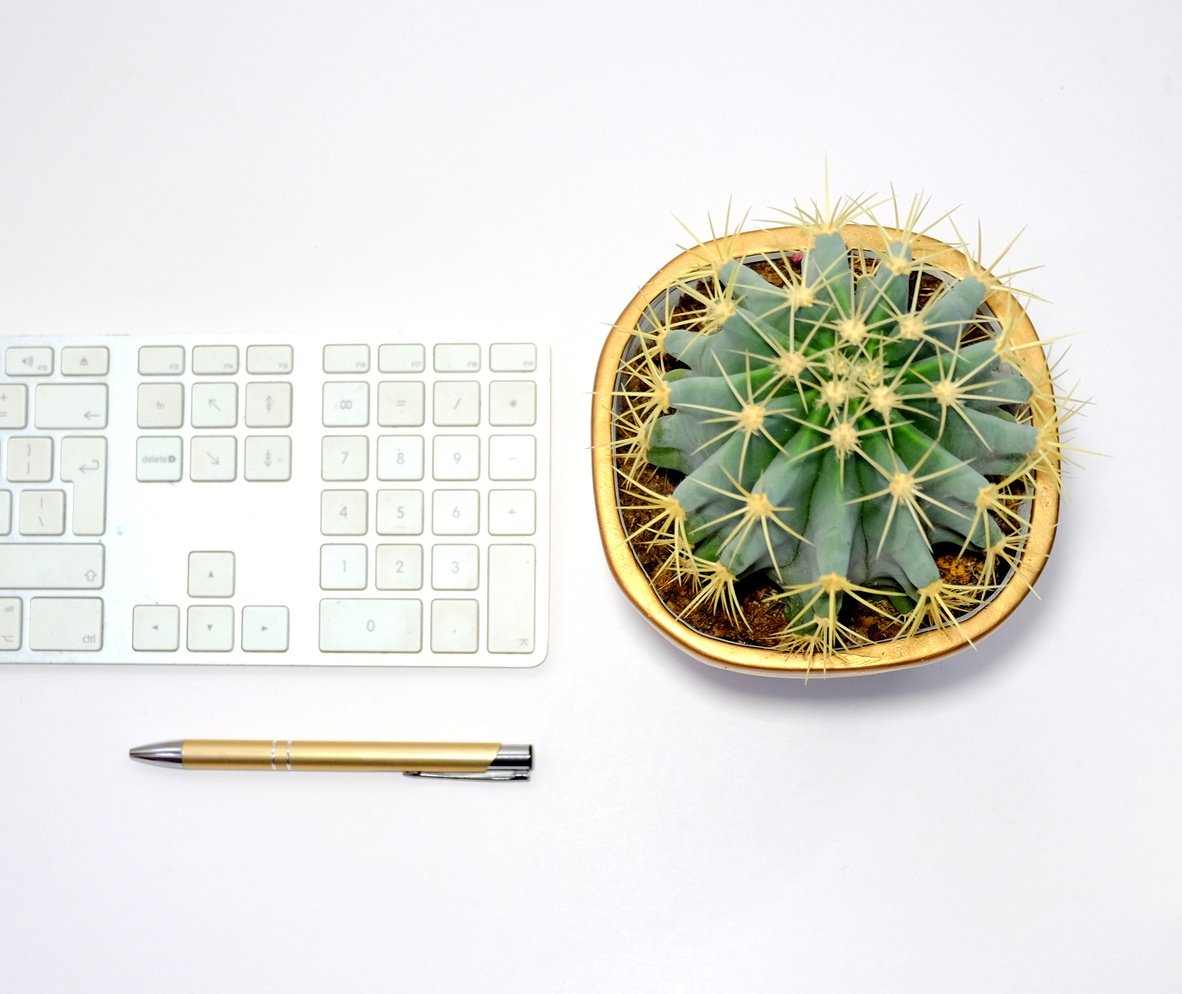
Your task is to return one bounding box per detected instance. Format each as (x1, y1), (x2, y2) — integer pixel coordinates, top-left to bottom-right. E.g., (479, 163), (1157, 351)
(307, 343), (545, 652)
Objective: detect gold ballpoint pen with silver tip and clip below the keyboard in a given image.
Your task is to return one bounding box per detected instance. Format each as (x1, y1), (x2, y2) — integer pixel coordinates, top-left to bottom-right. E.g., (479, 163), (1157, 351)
(130, 739), (533, 780)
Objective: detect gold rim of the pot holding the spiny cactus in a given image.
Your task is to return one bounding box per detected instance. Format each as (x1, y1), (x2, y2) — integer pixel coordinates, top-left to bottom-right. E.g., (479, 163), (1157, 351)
(591, 225), (1059, 677)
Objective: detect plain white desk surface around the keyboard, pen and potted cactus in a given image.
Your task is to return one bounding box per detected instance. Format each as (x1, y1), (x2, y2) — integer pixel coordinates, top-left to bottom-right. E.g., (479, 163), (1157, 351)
(0, 0), (1182, 994)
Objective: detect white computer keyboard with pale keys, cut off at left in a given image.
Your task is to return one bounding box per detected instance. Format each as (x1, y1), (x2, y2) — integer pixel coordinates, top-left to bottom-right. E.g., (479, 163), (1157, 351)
(0, 334), (550, 667)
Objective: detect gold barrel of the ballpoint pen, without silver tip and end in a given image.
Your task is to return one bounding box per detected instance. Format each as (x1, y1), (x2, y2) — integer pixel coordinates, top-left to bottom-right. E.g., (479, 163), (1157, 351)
(181, 739), (501, 773)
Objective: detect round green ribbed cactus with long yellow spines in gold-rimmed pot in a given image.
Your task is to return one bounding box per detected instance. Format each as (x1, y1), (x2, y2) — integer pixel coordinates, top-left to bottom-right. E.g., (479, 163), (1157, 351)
(615, 193), (1061, 657)
